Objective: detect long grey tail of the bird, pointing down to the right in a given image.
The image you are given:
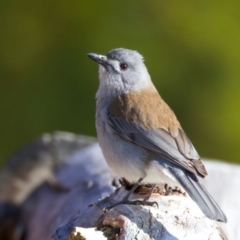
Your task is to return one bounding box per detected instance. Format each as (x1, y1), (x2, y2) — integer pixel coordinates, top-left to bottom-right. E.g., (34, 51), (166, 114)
(169, 168), (227, 222)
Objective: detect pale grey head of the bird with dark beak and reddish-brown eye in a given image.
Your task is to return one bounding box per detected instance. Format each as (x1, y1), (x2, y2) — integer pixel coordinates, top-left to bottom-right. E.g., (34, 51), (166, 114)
(88, 48), (152, 93)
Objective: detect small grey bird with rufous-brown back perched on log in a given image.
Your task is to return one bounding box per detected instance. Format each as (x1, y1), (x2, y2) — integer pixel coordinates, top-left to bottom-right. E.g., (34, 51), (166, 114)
(87, 48), (227, 222)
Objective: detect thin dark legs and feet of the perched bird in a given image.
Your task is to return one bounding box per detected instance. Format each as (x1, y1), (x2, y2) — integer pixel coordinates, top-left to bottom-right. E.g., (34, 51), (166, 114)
(106, 177), (158, 210)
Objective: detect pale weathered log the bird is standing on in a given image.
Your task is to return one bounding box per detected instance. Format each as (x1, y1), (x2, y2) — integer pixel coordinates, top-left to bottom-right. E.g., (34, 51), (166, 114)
(0, 133), (236, 240)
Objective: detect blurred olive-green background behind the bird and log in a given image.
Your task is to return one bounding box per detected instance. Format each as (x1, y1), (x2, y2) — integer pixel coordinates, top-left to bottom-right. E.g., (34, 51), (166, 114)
(0, 0), (240, 163)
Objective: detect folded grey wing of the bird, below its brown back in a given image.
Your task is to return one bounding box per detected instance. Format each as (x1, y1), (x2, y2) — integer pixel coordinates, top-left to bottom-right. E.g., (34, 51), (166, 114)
(108, 112), (207, 177)
